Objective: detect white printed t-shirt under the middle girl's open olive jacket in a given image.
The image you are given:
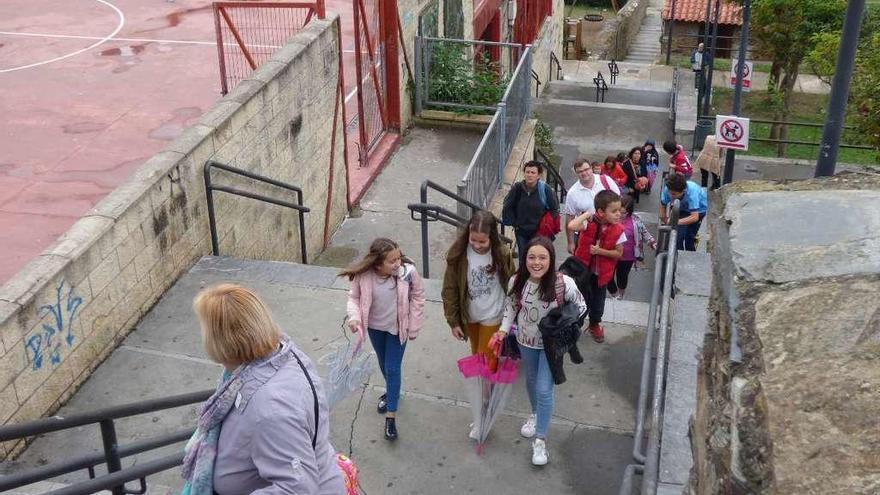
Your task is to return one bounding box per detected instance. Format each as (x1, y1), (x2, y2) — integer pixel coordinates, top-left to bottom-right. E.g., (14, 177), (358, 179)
(467, 245), (505, 325)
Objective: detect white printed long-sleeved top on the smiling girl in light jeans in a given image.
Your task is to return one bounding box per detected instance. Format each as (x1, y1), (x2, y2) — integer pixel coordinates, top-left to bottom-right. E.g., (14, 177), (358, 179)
(500, 275), (587, 349)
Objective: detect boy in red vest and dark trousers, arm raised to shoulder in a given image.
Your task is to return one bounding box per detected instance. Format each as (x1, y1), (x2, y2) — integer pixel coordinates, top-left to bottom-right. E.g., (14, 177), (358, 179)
(568, 190), (626, 343)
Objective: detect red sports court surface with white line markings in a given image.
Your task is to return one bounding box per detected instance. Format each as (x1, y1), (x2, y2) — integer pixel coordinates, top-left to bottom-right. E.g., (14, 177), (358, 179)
(0, 0), (370, 285)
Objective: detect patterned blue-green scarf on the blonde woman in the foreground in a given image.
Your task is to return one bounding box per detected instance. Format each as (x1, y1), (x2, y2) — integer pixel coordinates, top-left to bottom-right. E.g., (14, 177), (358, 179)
(181, 365), (250, 495)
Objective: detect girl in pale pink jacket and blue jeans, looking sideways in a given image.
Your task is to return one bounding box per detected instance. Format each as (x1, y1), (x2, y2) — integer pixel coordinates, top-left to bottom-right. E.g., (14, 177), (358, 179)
(339, 238), (425, 440)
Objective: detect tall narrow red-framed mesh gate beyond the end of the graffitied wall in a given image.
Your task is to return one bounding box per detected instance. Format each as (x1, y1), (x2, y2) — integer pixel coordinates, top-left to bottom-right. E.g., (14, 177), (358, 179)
(352, 0), (388, 167)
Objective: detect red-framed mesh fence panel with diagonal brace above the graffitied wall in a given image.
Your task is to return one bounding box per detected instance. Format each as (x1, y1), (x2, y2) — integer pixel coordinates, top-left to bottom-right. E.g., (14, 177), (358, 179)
(214, 0), (326, 95)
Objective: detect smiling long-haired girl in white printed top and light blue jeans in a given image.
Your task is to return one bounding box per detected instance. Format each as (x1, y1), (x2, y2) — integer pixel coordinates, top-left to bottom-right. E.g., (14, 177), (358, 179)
(493, 237), (586, 466)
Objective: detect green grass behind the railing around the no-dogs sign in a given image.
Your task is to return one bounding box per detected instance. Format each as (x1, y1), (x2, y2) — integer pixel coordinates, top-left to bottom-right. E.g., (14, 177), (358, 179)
(709, 88), (880, 165)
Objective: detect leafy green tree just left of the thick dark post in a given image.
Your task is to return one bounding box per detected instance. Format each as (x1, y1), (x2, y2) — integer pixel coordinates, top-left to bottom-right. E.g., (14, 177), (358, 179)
(752, 0), (846, 156)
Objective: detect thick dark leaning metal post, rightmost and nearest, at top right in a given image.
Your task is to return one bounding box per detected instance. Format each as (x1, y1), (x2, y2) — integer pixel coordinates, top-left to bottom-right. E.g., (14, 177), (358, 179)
(815, 0), (865, 177)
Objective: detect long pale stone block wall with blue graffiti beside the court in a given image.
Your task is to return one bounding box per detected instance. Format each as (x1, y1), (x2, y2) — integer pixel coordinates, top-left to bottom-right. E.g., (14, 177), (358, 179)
(0, 17), (347, 456)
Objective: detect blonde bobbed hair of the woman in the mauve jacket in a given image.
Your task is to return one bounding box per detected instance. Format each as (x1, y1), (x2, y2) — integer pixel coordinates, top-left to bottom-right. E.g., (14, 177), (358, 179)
(193, 284), (281, 365)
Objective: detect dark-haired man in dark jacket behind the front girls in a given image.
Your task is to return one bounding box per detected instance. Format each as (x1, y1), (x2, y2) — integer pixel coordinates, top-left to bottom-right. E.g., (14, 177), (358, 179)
(501, 161), (559, 259)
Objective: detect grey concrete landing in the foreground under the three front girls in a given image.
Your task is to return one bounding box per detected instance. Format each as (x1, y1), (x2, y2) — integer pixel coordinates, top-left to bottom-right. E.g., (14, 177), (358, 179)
(6, 257), (647, 495)
